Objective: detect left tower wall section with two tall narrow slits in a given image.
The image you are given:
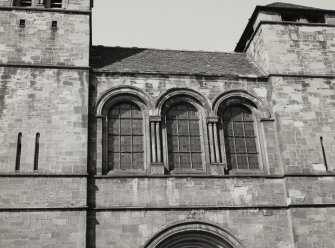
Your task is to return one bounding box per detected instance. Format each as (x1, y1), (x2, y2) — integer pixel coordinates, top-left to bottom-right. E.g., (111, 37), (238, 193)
(0, 67), (88, 173)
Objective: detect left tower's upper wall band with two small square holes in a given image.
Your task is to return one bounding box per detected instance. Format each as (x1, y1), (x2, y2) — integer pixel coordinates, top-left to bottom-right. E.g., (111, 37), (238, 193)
(0, 9), (90, 67)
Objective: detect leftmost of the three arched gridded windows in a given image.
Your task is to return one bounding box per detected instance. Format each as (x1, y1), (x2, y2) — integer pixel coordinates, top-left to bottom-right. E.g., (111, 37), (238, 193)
(108, 102), (144, 170)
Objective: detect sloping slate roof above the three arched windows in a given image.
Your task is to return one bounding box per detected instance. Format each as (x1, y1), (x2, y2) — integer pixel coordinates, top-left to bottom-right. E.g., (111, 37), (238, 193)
(91, 46), (264, 77)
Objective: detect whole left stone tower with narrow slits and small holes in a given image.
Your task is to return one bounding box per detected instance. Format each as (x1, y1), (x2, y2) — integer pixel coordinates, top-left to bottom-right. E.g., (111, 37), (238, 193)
(0, 0), (91, 247)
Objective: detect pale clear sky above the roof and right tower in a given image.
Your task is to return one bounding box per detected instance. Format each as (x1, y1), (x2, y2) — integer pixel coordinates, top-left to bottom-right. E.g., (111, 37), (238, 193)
(92, 0), (335, 52)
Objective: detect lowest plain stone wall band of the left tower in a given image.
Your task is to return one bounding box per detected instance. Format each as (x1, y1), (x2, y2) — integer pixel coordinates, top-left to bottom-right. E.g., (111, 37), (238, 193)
(0, 211), (86, 248)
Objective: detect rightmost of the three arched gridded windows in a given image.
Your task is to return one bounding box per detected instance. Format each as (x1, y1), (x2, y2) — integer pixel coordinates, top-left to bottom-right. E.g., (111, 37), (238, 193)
(221, 105), (260, 170)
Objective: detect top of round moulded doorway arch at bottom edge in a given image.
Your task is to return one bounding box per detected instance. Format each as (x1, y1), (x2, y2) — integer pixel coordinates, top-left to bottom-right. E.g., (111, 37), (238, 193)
(142, 221), (245, 248)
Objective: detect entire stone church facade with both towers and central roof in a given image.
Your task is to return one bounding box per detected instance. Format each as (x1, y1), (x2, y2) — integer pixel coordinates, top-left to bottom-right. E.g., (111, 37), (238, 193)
(0, 0), (335, 248)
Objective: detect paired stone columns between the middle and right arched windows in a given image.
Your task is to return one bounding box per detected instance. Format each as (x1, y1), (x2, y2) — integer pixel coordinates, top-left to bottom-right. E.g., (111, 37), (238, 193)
(207, 117), (225, 175)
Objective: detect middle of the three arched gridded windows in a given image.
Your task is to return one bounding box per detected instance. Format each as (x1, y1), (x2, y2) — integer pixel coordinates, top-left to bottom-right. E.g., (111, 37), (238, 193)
(166, 103), (203, 170)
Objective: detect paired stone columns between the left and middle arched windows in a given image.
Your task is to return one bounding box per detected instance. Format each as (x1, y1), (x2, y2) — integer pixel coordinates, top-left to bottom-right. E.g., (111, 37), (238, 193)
(149, 116), (165, 174)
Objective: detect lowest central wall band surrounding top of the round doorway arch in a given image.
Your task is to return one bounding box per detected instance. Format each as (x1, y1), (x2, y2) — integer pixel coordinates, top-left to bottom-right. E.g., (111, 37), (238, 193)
(91, 209), (294, 248)
